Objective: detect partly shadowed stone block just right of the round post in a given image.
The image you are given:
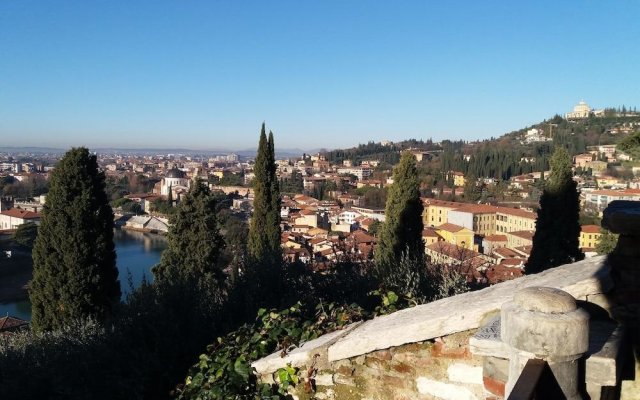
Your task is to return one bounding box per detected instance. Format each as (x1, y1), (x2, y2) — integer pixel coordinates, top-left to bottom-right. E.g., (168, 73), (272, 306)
(585, 321), (622, 386)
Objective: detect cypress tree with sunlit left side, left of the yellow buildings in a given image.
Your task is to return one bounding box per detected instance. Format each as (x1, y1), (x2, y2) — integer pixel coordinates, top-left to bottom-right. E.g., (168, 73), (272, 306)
(375, 153), (424, 270)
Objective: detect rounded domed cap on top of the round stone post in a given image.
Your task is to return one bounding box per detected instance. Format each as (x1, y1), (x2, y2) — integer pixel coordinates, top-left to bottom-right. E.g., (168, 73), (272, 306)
(513, 286), (578, 314)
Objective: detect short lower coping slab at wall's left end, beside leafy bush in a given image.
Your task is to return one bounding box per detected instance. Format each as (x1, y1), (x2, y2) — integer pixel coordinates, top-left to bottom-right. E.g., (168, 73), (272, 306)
(251, 322), (361, 374)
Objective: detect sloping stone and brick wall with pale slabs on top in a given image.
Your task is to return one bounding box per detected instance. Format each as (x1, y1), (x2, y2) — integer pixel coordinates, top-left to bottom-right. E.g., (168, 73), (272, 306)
(253, 257), (611, 400)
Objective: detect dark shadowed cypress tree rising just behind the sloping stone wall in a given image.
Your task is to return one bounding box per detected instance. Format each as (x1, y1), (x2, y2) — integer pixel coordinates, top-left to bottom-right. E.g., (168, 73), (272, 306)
(525, 147), (584, 274)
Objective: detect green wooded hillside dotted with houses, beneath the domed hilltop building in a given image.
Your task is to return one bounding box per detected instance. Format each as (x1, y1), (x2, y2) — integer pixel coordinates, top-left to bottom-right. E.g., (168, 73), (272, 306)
(323, 108), (640, 179)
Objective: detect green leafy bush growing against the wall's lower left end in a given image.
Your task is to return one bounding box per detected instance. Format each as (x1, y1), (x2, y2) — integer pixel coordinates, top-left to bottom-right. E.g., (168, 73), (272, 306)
(176, 303), (367, 400)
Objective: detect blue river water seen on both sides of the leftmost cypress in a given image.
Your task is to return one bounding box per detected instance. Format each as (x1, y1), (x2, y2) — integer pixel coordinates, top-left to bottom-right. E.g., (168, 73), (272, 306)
(0, 229), (167, 320)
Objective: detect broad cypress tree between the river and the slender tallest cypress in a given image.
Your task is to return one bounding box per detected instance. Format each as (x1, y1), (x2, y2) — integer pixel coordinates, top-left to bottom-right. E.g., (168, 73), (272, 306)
(153, 180), (224, 285)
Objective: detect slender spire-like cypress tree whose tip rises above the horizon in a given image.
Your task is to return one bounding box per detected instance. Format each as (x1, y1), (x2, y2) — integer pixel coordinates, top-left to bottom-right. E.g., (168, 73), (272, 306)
(247, 123), (282, 265)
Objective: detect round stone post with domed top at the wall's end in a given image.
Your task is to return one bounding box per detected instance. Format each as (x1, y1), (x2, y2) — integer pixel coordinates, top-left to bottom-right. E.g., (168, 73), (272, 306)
(500, 287), (589, 399)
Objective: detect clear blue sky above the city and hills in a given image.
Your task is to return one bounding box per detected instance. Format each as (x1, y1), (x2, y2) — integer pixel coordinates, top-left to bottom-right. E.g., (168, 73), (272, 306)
(0, 0), (640, 149)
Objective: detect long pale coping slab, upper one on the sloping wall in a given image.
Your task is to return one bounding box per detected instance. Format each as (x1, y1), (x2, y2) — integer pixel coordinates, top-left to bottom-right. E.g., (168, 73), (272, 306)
(328, 256), (611, 361)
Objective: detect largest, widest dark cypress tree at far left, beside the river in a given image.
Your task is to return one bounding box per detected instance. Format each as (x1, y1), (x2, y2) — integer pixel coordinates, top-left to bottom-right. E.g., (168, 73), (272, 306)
(29, 147), (120, 331)
